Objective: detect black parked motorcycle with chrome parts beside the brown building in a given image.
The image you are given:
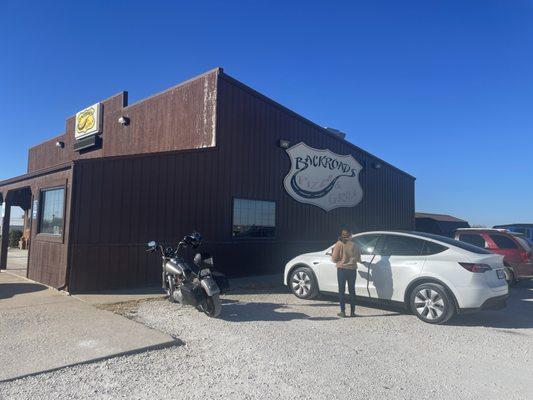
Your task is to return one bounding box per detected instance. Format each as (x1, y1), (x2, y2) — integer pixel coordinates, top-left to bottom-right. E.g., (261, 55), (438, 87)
(147, 232), (229, 318)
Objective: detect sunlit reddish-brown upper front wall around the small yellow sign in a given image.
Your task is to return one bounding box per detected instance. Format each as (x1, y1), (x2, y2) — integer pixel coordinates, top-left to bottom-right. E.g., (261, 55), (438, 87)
(28, 69), (219, 172)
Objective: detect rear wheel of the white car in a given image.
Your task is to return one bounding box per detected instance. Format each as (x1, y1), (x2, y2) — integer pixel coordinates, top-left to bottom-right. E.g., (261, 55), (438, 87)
(410, 283), (455, 324)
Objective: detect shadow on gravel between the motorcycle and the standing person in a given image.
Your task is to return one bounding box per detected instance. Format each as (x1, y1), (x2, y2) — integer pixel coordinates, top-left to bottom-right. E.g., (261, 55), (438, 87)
(219, 301), (338, 322)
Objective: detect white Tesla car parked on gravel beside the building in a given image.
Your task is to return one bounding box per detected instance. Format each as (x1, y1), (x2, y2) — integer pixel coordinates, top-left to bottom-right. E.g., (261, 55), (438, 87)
(284, 231), (509, 324)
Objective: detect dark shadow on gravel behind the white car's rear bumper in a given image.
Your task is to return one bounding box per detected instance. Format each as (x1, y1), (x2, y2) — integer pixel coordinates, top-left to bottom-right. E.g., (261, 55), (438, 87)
(447, 280), (533, 333)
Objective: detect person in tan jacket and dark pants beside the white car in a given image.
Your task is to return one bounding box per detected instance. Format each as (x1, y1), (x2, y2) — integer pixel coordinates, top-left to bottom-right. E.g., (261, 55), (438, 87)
(331, 228), (361, 318)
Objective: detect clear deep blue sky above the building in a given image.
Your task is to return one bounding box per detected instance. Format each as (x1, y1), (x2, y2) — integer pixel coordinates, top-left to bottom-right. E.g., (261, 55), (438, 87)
(0, 0), (533, 225)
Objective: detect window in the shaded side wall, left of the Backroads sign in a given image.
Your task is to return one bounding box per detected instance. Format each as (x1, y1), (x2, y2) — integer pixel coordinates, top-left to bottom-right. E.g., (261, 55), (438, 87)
(233, 199), (276, 238)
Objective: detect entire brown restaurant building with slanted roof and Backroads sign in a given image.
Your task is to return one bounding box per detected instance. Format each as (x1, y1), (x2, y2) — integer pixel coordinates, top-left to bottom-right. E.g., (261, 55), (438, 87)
(0, 68), (414, 292)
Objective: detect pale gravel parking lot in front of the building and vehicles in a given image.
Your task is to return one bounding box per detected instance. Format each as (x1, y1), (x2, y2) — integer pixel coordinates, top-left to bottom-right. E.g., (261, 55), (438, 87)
(0, 283), (533, 400)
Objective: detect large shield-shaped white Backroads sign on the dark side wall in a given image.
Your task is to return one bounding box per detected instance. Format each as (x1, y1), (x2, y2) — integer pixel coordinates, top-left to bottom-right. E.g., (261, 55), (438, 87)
(283, 142), (363, 211)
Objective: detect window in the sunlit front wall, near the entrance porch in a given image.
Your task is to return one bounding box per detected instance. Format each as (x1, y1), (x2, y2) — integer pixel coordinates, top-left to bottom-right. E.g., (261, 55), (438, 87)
(39, 188), (65, 236)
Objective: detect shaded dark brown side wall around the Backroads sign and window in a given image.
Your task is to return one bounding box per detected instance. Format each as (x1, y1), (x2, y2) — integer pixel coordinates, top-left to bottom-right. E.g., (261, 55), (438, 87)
(66, 72), (414, 292)
